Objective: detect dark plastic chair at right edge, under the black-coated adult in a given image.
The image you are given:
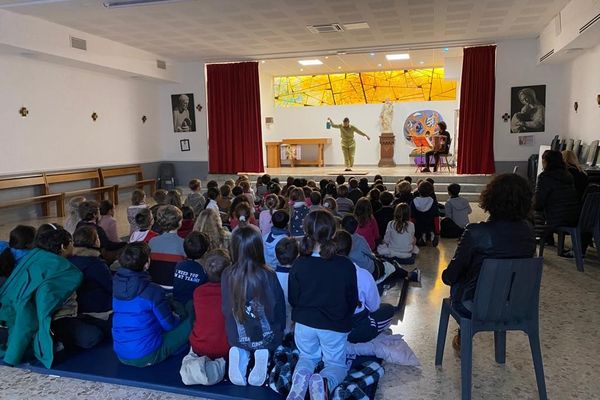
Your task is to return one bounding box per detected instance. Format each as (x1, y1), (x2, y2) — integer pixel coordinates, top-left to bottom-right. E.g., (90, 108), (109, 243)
(539, 185), (600, 272)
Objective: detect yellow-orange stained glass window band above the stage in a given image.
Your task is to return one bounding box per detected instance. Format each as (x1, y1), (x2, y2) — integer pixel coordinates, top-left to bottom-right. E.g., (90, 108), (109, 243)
(273, 68), (456, 107)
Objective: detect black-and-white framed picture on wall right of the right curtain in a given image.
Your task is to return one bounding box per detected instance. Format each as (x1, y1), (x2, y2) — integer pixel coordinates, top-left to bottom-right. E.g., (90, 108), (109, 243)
(510, 85), (546, 133)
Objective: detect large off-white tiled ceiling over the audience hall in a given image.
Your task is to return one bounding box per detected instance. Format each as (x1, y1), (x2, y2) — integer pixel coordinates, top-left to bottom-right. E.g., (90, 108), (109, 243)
(0, 0), (568, 61)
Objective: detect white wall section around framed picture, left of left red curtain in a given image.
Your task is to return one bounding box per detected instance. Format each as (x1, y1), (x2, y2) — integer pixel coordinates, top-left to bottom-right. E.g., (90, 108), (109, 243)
(160, 62), (208, 161)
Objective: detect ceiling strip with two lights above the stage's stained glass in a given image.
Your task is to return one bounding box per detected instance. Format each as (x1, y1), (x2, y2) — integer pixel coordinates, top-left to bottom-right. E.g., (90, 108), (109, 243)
(260, 48), (463, 76)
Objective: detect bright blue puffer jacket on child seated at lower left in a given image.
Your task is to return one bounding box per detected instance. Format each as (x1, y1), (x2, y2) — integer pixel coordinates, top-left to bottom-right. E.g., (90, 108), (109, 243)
(112, 268), (180, 360)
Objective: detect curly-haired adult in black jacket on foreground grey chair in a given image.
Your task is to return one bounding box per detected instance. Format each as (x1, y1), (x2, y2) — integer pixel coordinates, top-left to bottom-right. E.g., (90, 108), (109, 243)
(442, 174), (536, 350)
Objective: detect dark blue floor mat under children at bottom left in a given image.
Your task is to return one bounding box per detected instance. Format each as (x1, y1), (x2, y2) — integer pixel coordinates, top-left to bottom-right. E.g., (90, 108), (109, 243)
(24, 343), (284, 400)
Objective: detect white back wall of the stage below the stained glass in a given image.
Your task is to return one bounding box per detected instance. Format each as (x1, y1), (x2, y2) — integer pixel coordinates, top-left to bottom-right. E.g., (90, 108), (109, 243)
(260, 68), (458, 165)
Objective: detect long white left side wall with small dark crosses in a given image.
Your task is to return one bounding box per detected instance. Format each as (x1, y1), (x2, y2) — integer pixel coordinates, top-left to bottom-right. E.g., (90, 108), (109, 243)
(0, 54), (161, 174)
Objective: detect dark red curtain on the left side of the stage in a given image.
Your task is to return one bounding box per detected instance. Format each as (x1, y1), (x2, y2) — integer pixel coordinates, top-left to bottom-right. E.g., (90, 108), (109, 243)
(206, 62), (264, 174)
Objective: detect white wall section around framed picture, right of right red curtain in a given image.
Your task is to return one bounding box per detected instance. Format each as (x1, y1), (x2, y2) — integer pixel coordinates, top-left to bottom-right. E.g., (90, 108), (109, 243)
(494, 39), (569, 161)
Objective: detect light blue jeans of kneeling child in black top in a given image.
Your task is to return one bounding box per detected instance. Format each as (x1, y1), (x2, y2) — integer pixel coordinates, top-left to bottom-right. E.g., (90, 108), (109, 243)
(294, 322), (348, 392)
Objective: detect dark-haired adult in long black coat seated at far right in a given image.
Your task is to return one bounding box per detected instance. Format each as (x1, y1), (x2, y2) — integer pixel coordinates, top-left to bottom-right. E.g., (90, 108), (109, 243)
(533, 150), (580, 255)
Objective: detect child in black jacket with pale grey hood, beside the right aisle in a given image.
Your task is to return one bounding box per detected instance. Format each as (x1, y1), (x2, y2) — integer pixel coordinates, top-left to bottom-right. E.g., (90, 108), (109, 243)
(410, 181), (440, 247)
